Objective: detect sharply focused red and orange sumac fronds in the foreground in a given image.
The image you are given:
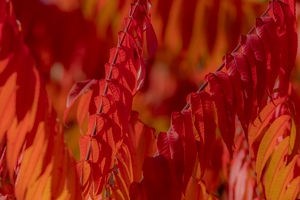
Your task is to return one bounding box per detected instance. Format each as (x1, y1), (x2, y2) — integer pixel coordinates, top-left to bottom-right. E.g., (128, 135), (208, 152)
(0, 0), (300, 200)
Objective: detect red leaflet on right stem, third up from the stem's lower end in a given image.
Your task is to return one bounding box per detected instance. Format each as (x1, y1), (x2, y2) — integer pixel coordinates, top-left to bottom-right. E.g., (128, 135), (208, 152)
(187, 91), (217, 175)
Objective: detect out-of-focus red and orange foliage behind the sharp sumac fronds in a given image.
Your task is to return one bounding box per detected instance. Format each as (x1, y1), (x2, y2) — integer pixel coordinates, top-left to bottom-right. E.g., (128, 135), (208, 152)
(12, 0), (300, 160)
